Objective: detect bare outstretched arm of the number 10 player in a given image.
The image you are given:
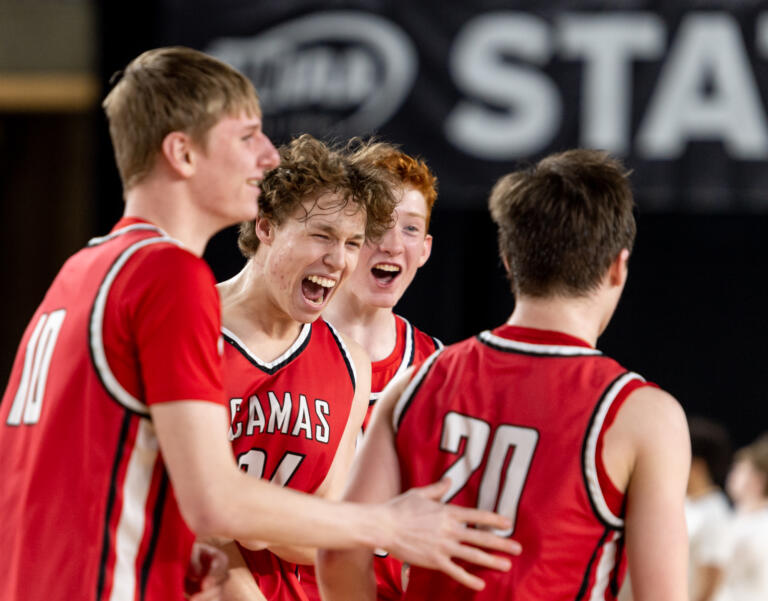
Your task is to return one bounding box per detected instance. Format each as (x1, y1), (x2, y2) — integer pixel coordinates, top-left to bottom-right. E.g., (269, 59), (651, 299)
(150, 401), (516, 582)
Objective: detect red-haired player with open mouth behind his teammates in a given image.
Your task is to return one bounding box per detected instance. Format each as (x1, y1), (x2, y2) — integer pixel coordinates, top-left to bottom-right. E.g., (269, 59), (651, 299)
(301, 142), (442, 601)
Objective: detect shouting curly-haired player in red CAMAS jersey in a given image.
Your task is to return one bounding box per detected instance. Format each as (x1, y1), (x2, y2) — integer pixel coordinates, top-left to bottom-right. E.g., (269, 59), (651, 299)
(214, 134), (394, 601)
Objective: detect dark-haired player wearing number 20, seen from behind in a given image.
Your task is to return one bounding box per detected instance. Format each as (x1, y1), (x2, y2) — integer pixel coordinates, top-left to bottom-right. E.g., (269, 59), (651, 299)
(318, 150), (690, 601)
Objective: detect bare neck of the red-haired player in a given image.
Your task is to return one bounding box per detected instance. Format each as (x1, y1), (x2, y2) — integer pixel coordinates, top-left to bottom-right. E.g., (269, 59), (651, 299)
(323, 294), (397, 361)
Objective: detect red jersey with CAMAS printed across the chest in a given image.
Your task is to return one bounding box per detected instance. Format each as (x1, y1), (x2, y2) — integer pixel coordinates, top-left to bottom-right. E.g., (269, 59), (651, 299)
(223, 319), (356, 601)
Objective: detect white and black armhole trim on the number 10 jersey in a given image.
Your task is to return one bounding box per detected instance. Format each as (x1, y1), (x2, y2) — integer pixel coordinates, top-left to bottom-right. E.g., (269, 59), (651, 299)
(88, 236), (181, 417)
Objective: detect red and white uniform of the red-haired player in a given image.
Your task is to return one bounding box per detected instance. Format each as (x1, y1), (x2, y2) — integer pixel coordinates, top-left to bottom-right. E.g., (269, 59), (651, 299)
(299, 315), (443, 601)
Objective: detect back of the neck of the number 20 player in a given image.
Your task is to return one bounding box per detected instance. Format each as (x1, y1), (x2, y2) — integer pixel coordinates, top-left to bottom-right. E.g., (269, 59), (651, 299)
(507, 296), (602, 346)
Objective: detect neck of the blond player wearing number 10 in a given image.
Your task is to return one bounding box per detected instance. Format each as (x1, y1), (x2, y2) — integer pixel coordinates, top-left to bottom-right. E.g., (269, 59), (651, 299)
(123, 180), (227, 257)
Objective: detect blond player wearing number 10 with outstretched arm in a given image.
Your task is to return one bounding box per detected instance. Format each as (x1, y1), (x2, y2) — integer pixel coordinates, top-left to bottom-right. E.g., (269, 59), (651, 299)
(0, 48), (517, 601)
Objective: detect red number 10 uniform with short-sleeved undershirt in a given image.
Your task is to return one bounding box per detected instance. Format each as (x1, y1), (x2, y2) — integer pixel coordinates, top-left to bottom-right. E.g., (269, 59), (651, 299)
(0, 219), (224, 601)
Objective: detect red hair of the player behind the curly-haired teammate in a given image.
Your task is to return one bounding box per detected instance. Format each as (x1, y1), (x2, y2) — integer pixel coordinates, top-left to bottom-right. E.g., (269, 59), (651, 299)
(349, 138), (437, 231)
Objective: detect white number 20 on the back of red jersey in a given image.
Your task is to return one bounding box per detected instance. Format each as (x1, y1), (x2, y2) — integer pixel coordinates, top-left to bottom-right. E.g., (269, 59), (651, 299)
(440, 411), (539, 536)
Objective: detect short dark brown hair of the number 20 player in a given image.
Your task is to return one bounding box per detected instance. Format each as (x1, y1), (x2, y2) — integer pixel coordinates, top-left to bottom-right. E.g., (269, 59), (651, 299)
(489, 149), (636, 297)
